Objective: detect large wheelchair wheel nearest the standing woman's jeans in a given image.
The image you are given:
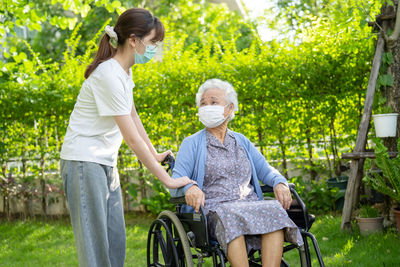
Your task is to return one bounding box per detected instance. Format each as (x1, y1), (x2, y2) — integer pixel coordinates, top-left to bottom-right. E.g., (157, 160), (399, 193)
(147, 210), (194, 267)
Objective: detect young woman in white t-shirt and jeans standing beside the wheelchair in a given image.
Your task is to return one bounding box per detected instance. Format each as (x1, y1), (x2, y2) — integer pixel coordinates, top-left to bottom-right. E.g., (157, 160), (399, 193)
(60, 8), (193, 267)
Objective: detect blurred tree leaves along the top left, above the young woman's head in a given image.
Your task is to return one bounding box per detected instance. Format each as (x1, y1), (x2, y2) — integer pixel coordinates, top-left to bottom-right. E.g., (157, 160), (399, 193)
(0, 0), (255, 61)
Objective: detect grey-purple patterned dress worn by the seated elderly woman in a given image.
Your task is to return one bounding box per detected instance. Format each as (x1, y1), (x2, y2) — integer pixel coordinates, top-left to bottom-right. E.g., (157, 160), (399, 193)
(203, 130), (302, 255)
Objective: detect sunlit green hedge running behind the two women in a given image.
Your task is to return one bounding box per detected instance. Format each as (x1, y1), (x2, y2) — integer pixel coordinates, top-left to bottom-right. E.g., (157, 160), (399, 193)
(0, 14), (373, 176)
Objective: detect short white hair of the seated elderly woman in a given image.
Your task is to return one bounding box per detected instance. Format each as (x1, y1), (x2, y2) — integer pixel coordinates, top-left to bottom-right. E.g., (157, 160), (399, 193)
(196, 79), (239, 120)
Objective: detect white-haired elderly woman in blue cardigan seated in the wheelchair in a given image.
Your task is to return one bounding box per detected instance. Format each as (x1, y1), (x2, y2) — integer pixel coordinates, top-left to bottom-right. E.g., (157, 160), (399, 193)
(171, 79), (302, 267)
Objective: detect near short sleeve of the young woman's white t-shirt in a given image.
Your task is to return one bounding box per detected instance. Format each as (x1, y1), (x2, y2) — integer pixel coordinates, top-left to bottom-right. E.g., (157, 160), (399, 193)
(91, 71), (132, 116)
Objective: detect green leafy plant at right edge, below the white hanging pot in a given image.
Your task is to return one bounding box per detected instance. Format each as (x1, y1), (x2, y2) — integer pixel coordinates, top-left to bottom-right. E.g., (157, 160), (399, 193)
(363, 138), (400, 204)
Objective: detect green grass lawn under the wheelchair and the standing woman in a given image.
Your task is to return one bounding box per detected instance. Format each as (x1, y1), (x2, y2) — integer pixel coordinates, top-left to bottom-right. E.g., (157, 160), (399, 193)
(0, 214), (400, 267)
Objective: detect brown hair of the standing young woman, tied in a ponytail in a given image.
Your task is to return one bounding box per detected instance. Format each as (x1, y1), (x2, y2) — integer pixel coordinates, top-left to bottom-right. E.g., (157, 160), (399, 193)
(85, 8), (165, 79)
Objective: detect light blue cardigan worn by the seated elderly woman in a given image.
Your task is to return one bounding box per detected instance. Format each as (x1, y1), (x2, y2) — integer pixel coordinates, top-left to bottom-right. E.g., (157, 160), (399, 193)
(170, 129), (287, 212)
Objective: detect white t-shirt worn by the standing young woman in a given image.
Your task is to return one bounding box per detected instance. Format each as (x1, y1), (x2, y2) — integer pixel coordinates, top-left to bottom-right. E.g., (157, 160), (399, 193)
(60, 59), (135, 166)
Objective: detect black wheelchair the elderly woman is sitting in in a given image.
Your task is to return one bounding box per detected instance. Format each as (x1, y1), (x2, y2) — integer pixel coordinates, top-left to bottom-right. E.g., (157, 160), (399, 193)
(146, 157), (325, 267)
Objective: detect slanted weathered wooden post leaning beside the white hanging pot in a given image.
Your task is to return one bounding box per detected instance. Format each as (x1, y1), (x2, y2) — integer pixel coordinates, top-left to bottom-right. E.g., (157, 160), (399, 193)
(341, 33), (385, 230)
